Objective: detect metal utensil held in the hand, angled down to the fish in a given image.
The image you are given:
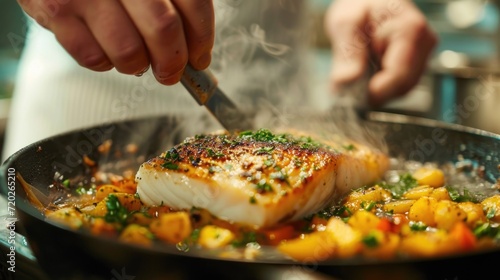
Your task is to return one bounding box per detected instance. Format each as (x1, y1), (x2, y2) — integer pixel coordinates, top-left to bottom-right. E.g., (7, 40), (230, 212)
(181, 64), (254, 131)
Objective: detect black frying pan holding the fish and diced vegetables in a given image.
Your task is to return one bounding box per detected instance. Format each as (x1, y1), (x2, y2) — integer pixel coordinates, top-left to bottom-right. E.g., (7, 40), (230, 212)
(0, 112), (500, 280)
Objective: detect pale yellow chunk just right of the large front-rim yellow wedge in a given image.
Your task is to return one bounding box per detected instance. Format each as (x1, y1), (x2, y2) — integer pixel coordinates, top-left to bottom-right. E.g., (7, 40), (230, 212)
(325, 217), (363, 258)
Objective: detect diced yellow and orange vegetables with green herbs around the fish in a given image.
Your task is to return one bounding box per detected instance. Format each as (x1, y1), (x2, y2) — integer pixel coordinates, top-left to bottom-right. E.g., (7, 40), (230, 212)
(46, 164), (500, 262)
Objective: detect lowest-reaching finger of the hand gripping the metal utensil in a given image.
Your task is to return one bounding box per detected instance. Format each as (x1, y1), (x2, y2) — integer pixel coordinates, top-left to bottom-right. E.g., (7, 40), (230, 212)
(122, 0), (188, 85)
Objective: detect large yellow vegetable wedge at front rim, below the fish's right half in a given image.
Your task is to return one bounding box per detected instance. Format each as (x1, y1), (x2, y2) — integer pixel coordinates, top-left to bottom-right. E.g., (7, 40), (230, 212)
(277, 231), (337, 263)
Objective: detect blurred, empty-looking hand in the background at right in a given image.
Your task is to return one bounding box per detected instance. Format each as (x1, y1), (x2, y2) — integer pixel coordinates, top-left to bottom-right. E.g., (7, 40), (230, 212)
(325, 0), (437, 106)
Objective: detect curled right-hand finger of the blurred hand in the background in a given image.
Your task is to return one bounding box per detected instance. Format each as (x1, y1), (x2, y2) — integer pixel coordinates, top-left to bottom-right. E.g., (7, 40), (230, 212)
(369, 19), (437, 106)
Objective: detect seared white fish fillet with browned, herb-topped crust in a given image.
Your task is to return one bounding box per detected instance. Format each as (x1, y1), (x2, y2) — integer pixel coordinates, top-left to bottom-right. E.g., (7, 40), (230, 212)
(136, 129), (389, 227)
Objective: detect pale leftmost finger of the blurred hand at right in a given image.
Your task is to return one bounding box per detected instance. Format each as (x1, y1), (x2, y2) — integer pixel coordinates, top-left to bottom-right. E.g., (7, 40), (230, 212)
(325, 1), (370, 91)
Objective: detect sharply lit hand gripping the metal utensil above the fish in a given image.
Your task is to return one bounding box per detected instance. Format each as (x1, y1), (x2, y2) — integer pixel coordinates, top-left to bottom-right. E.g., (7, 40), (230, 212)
(18, 0), (214, 85)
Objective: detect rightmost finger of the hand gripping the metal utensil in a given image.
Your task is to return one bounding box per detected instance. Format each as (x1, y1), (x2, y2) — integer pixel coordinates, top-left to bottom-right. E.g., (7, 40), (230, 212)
(173, 0), (215, 70)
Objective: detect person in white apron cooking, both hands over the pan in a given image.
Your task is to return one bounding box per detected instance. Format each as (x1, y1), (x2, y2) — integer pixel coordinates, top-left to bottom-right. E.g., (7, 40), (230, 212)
(3, 0), (437, 159)
